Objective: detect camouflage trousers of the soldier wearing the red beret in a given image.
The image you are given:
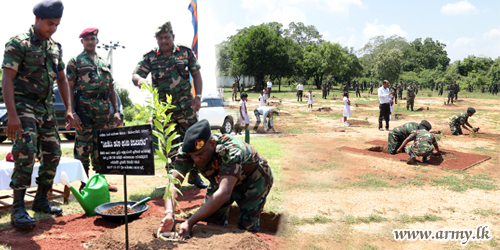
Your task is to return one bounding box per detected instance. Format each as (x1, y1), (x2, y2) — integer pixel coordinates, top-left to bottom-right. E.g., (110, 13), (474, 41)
(73, 98), (111, 173)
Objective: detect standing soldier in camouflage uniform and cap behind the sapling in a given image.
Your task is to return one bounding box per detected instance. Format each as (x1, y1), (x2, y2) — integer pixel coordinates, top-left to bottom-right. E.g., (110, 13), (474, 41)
(132, 21), (206, 188)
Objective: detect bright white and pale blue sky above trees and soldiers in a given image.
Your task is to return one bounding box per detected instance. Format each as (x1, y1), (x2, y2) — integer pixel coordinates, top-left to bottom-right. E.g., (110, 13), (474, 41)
(0, 0), (500, 102)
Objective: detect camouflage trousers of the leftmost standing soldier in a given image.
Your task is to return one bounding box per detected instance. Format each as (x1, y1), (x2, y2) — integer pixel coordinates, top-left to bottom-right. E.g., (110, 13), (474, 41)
(10, 103), (61, 189)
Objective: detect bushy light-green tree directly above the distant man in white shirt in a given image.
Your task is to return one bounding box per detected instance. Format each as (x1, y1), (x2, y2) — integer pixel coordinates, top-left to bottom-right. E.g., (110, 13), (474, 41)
(373, 49), (403, 83)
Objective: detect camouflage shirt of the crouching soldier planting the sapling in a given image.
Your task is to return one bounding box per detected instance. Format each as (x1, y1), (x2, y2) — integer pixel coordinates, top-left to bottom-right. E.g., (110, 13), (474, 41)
(174, 134), (271, 187)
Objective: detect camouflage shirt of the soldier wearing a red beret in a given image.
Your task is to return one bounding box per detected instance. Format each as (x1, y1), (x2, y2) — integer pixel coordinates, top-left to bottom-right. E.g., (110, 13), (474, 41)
(66, 51), (113, 94)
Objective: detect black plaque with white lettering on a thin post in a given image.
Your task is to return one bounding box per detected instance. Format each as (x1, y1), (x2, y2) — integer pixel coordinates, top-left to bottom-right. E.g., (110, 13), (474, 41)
(97, 125), (155, 175)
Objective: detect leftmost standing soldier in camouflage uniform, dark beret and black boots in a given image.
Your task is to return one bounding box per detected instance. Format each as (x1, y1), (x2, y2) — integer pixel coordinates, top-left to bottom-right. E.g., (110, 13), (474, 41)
(2, 0), (79, 228)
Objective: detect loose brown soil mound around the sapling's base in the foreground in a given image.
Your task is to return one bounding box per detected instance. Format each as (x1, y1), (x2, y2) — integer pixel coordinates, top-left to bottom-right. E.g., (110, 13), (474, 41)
(88, 216), (268, 250)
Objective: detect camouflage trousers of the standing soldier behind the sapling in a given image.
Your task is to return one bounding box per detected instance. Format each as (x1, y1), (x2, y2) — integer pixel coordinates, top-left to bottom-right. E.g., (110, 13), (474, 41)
(165, 104), (198, 157)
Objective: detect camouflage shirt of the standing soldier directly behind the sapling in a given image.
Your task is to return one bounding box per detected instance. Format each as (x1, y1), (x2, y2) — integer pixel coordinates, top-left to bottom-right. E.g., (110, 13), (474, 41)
(134, 45), (201, 110)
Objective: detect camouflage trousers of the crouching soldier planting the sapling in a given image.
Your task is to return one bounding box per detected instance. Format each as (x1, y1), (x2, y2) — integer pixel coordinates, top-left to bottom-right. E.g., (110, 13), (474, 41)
(205, 159), (273, 232)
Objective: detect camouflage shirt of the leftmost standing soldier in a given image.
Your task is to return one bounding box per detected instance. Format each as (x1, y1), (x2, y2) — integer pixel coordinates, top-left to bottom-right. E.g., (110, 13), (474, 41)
(2, 26), (64, 106)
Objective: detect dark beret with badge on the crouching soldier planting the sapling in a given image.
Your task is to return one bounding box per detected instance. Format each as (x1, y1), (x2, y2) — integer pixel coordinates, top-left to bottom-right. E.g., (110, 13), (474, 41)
(182, 119), (212, 153)
